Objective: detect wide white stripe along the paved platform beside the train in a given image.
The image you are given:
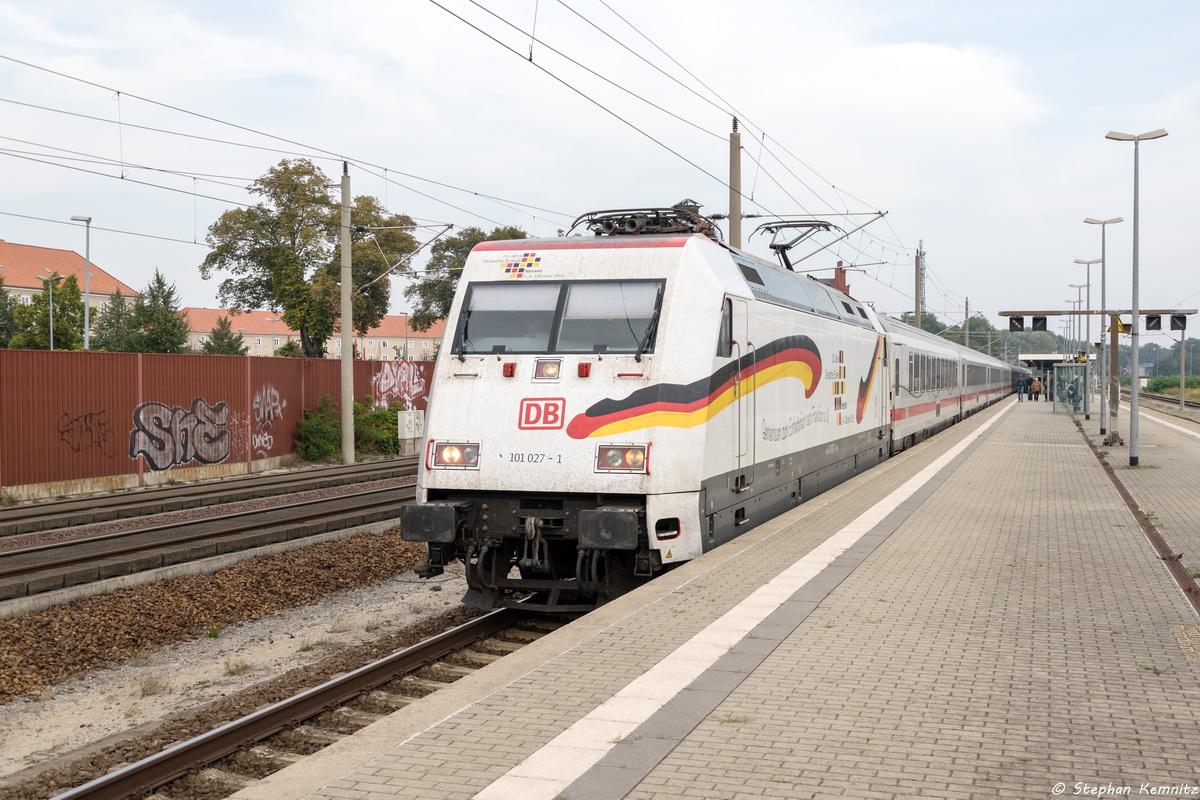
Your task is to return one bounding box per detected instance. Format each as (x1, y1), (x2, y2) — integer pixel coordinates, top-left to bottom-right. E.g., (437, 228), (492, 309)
(475, 405), (1014, 800)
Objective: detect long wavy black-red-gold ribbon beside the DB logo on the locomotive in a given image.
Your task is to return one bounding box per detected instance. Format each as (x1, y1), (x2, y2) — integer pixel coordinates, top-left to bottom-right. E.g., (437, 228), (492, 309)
(566, 336), (821, 439)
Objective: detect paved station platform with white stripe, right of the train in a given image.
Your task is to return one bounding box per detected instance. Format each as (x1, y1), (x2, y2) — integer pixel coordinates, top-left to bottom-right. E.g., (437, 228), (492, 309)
(226, 397), (1200, 800)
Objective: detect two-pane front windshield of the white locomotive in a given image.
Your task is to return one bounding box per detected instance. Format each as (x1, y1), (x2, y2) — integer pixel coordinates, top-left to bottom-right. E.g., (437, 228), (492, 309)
(455, 281), (662, 353)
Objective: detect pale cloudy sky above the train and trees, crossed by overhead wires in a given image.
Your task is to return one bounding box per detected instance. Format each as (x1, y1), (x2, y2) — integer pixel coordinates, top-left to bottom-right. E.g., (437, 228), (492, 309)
(0, 0), (1200, 344)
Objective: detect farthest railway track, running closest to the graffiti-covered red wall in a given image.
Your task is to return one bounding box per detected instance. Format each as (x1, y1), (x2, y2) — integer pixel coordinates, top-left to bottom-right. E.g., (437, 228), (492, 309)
(0, 458), (416, 537)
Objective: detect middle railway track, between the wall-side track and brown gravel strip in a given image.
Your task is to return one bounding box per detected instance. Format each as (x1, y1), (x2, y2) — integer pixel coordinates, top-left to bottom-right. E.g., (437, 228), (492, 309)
(0, 486), (415, 600)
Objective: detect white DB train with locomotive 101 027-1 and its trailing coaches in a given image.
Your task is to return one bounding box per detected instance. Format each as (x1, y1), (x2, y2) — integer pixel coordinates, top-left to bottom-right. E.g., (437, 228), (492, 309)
(401, 204), (1012, 610)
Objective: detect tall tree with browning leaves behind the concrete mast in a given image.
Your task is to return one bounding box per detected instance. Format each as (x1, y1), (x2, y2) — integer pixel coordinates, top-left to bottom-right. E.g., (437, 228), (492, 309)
(200, 158), (416, 357)
